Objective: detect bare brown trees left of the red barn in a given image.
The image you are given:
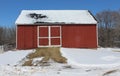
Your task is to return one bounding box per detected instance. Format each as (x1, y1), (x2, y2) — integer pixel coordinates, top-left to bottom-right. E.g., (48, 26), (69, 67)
(0, 26), (16, 50)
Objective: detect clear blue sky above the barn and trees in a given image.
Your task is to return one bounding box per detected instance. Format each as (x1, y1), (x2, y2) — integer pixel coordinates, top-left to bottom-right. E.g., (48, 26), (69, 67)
(0, 0), (120, 26)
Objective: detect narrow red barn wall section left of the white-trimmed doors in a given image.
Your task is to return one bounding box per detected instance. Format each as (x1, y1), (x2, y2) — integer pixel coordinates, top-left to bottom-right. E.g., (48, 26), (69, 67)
(16, 25), (37, 49)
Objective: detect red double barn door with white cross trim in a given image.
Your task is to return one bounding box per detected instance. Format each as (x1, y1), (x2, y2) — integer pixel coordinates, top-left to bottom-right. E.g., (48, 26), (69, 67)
(38, 26), (61, 47)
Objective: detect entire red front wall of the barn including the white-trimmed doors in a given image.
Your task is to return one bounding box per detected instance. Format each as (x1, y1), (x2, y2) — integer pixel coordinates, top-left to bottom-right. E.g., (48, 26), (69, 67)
(17, 24), (97, 49)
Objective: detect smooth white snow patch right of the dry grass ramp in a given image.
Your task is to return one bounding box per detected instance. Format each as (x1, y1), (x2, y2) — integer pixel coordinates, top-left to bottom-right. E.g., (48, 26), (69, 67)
(61, 48), (120, 67)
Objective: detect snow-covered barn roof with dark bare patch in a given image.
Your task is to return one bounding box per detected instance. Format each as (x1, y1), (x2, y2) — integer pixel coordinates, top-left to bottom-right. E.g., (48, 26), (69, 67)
(15, 10), (97, 24)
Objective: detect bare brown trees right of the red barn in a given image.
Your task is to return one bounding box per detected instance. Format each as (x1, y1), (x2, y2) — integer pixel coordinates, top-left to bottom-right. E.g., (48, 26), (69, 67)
(96, 10), (120, 47)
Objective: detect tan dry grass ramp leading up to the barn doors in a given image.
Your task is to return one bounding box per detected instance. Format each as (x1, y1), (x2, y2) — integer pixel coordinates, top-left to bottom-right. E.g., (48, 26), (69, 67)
(23, 47), (67, 66)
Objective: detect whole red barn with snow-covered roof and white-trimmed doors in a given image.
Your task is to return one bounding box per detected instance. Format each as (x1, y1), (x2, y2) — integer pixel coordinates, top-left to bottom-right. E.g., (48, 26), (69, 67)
(16, 10), (98, 49)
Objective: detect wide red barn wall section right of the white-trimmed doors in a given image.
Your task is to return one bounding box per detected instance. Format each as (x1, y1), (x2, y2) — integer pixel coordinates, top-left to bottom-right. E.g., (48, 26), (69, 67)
(62, 24), (97, 48)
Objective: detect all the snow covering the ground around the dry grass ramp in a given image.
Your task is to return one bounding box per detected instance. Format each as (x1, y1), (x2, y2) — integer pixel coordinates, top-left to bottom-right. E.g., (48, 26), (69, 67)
(0, 48), (120, 76)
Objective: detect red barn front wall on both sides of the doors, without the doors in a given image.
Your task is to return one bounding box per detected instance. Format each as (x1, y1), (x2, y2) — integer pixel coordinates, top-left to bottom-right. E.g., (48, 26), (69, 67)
(16, 24), (97, 49)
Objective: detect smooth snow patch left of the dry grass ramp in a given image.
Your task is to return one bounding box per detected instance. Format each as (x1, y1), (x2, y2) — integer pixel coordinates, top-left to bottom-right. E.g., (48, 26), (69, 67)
(0, 50), (32, 65)
